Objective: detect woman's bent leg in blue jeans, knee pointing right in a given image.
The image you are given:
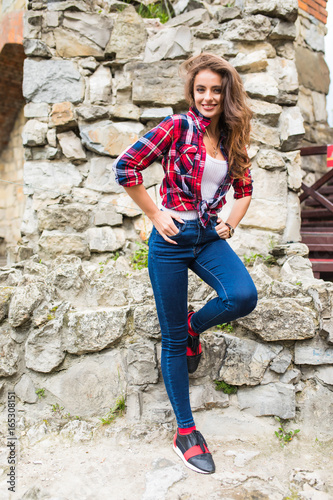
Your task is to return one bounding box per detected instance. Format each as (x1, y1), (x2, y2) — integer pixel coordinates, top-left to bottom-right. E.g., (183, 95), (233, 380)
(190, 239), (258, 333)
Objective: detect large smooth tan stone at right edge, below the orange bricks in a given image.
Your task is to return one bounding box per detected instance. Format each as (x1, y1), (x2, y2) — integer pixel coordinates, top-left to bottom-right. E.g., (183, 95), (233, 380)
(296, 45), (330, 94)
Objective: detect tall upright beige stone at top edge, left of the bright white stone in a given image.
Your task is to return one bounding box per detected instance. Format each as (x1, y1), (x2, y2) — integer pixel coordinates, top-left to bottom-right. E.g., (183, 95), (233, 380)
(105, 5), (147, 61)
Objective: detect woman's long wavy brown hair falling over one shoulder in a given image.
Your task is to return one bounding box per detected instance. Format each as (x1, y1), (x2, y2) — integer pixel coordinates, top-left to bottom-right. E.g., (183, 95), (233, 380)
(179, 52), (252, 179)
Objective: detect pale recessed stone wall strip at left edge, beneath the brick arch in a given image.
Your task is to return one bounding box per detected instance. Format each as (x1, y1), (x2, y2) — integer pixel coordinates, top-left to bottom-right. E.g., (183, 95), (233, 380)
(0, 109), (25, 256)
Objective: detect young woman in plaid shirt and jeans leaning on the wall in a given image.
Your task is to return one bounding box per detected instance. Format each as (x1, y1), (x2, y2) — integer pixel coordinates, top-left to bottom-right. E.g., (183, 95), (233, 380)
(113, 53), (257, 474)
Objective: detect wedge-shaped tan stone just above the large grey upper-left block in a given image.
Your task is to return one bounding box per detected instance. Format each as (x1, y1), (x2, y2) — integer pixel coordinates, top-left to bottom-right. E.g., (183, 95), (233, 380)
(54, 28), (104, 59)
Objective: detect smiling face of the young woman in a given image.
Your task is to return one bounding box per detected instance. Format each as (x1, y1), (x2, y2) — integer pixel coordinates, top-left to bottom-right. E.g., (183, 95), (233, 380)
(193, 69), (223, 119)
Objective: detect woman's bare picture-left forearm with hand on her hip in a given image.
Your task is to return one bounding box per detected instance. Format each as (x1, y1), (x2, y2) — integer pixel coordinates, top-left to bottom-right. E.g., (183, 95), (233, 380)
(124, 184), (183, 245)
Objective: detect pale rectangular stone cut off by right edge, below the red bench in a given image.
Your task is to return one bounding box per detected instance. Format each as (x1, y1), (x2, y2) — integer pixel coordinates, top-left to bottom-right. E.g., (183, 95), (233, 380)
(295, 336), (333, 365)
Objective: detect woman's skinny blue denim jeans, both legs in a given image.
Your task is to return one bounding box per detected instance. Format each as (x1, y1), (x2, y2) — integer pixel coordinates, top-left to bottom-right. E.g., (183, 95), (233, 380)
(148, 217), (257, 428)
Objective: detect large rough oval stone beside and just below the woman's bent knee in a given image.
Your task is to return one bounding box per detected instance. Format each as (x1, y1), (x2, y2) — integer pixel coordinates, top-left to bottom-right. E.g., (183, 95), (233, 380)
(237, 298), (318, 342)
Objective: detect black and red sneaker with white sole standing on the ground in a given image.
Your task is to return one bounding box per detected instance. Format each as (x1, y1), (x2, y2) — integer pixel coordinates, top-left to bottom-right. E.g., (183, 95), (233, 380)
(173, 429), (215, 474)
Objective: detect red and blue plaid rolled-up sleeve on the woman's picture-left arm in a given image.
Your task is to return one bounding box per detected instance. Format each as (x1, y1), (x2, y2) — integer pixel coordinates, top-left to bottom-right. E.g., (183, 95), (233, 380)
(112, 116), (173, 187)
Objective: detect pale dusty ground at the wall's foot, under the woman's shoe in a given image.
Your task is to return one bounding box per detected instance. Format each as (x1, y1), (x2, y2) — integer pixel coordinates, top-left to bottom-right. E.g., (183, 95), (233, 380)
(0, 407), (333, 500)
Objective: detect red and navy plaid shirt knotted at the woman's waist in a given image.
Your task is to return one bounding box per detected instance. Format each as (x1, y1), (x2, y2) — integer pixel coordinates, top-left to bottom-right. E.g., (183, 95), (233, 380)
(112, 107), (252, 226)
